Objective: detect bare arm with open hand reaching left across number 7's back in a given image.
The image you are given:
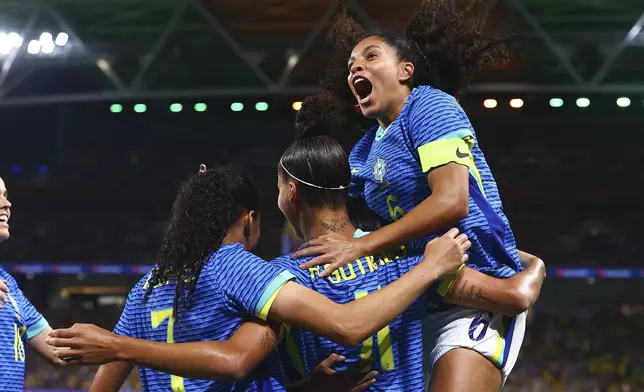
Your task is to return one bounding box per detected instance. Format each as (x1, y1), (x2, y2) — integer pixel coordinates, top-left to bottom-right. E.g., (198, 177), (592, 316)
(47, 320), (282, 380)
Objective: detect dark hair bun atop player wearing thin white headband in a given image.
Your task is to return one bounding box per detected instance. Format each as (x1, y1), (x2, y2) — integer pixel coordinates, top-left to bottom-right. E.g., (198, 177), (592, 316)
(295, 92), (345, 138)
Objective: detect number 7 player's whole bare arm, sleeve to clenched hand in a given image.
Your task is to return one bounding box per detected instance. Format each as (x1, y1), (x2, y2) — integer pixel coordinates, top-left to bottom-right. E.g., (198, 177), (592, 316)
(268, 229), (471, 346)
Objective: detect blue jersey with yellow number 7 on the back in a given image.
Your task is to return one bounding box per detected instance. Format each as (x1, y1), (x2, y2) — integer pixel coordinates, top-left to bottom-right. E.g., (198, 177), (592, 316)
(114, 244), (294, 392)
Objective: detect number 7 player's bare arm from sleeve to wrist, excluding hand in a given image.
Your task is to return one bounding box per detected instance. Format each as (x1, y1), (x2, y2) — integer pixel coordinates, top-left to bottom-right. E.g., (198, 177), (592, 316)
(269, 263), (438, 346)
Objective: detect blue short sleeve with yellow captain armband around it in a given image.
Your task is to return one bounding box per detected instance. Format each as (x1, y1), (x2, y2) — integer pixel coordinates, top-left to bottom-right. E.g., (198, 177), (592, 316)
(403, 87), (474, 173)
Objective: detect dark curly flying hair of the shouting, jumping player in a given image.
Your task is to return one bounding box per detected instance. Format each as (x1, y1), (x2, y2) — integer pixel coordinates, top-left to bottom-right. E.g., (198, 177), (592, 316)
(306, 0), (509, 141)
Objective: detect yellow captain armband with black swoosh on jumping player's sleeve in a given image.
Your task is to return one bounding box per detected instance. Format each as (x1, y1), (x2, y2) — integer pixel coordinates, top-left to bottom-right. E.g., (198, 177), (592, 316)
(418, 137), (472, 173)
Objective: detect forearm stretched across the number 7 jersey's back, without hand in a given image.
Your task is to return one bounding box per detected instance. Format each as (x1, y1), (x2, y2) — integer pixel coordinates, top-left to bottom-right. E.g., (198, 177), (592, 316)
(116, 336), (241, 381)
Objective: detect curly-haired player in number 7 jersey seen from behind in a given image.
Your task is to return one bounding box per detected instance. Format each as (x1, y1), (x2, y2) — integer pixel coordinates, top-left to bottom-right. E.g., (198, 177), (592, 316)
(51, 167), (469, 391)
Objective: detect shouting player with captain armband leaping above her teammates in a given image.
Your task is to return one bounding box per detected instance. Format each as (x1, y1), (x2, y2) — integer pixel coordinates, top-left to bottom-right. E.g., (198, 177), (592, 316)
(294, 0), (525, 391)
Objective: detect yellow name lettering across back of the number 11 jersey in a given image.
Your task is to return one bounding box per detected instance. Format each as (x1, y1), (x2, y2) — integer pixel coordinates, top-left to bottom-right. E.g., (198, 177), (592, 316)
(309, 245), (408, 284)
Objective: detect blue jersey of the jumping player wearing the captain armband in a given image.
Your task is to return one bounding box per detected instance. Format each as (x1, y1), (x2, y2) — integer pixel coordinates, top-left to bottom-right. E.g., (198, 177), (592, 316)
(349, 86), (521, 277)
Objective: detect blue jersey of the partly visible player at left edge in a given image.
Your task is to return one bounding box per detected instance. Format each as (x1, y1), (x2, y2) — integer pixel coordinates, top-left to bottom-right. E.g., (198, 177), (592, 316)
(0, 268), (49, 392)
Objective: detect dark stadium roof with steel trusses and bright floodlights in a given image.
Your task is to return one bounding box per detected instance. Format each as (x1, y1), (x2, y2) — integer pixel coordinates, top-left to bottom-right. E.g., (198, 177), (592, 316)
(0, 0), (644, 106)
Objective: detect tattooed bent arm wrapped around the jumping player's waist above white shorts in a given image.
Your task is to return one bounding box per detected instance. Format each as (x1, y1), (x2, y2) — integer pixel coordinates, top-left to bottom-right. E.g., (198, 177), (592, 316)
(445, 251), (546, 317)
